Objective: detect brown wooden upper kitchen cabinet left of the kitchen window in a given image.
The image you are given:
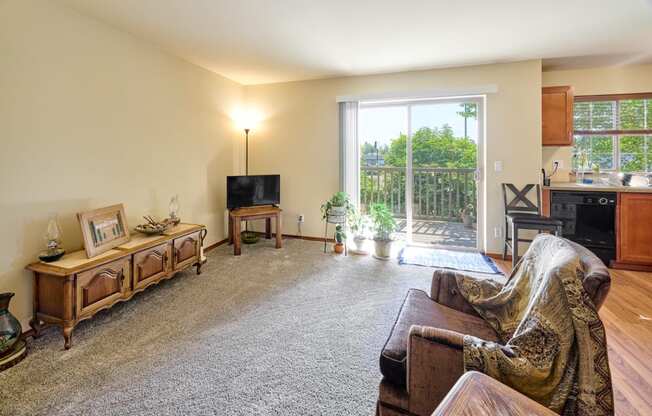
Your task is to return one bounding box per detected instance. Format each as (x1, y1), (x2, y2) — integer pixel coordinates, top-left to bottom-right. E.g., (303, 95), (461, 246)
(541, 86), (573, 146)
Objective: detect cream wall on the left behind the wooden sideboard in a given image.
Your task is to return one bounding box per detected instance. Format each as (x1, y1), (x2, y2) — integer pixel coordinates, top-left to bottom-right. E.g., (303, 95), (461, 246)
(0, 0), (243, 323)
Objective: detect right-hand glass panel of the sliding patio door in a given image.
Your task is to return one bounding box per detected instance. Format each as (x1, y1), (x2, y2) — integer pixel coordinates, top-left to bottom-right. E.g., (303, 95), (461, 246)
(407, 100), (479, 248)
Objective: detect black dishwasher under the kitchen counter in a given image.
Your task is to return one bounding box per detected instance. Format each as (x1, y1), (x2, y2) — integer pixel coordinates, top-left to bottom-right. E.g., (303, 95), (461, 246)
(550, 191), (617, 265)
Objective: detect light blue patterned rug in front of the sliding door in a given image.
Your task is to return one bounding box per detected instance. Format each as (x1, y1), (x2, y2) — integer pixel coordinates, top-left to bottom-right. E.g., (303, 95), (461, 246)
(398, 247), (502, 274)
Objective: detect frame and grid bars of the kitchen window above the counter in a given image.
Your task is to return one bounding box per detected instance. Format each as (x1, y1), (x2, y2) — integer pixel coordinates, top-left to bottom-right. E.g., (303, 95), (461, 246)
(573, 92), (652, 174)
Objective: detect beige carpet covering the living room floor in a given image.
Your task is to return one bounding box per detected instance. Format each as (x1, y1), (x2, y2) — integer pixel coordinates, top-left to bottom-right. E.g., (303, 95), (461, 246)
(0, 240), (432, 416)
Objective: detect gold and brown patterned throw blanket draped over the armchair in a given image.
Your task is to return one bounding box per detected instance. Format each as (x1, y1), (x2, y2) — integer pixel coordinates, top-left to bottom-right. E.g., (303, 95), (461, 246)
(457, 234), (613, 416)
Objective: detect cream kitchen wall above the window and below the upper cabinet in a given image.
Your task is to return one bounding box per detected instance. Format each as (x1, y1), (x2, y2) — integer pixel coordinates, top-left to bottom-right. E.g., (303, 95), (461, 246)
(542, 65), (652, 182)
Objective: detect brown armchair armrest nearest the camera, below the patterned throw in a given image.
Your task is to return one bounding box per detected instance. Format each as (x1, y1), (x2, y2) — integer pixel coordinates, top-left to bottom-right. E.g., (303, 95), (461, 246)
(406, 325), (464, 415)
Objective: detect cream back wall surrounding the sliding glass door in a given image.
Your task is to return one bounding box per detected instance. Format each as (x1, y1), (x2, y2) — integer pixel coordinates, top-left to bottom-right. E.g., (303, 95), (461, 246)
(245, 61), (541, 252)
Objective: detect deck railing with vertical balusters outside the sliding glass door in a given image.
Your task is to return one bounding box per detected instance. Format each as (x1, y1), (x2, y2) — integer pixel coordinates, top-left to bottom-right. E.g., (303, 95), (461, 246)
(360, 166), (477, 221)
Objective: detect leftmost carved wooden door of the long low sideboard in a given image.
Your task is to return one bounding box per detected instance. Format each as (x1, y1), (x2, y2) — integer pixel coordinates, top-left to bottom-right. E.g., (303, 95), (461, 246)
(76, 256), (131, 319)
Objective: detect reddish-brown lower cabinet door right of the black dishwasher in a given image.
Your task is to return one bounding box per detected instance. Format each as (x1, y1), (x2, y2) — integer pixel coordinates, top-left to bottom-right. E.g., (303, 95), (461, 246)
(617, 193), (652, 264)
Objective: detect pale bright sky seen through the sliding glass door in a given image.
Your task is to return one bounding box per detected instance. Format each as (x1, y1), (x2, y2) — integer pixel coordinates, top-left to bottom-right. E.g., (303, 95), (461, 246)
(358, 103), (478, 146)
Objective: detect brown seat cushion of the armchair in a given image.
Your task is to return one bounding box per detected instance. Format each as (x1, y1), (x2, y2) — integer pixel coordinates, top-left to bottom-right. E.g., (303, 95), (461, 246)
(380, 289), (498, 386)
